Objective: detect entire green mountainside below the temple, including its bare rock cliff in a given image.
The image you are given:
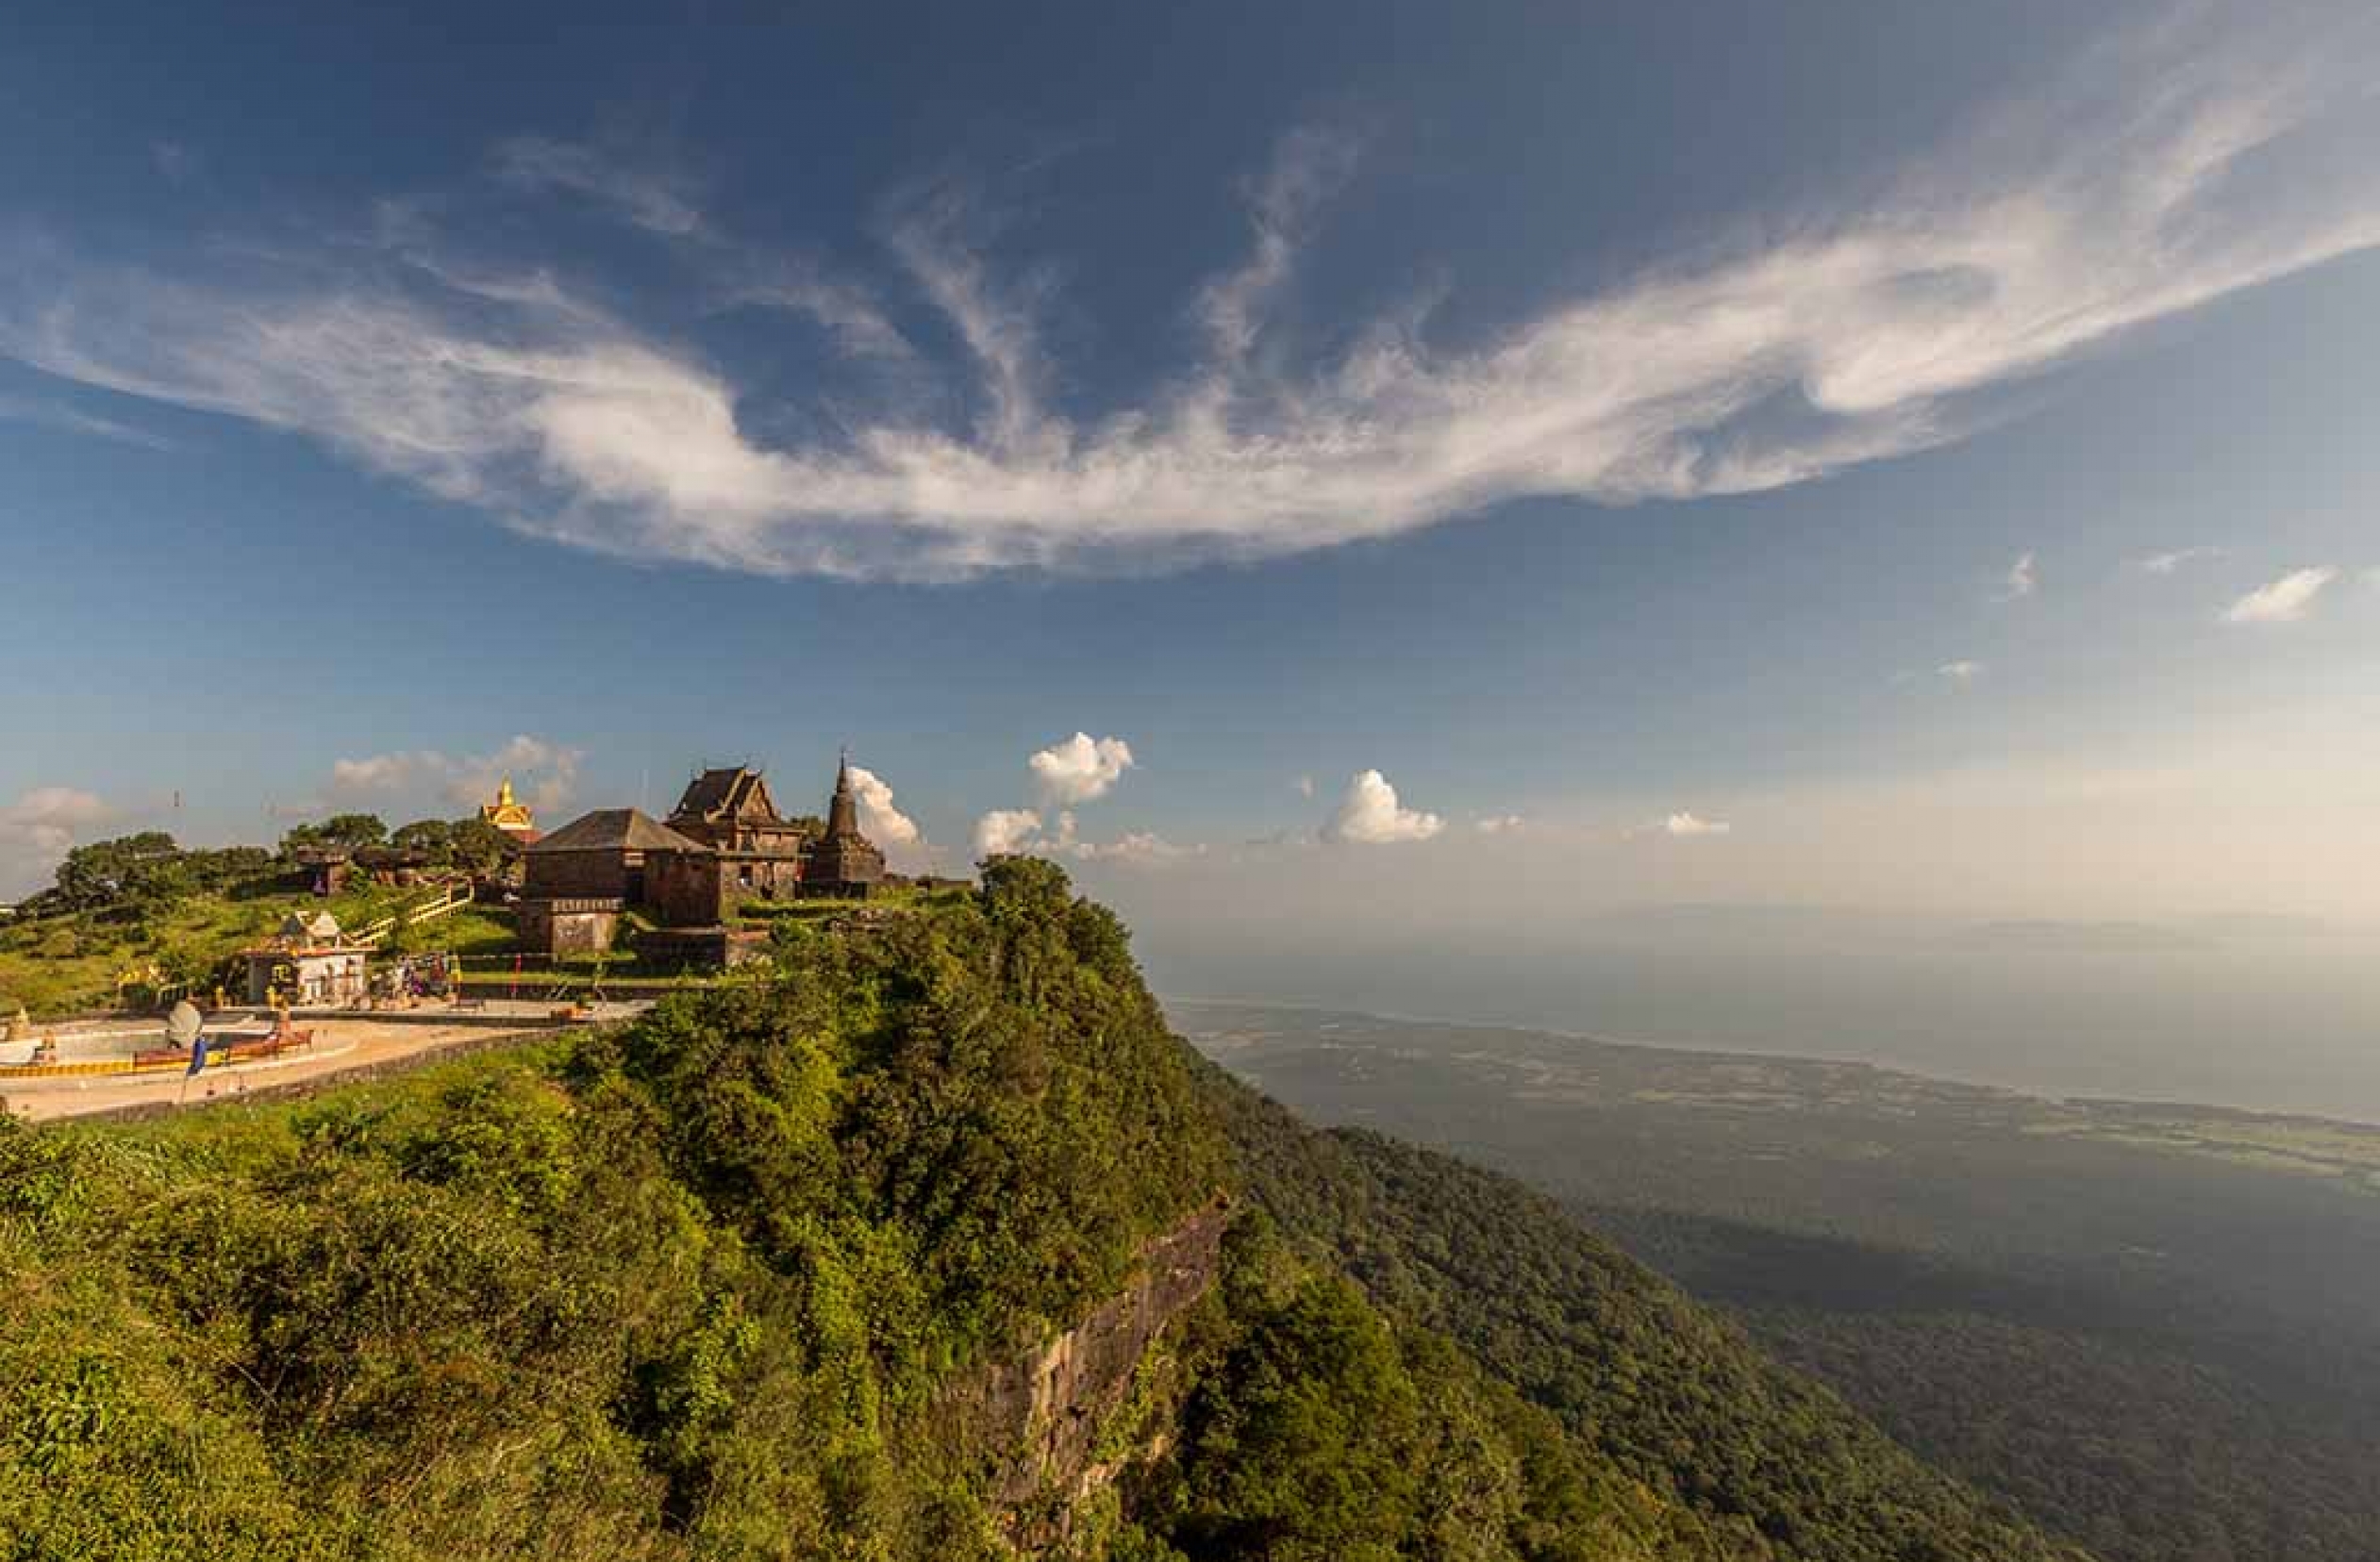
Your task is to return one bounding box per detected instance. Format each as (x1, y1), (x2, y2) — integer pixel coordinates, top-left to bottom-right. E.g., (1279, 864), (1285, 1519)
(0, 862), (2085, 1562)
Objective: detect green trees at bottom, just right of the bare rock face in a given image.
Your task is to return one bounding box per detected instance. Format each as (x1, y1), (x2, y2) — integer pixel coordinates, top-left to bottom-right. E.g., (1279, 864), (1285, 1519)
(1111, 1217), (1738, 1562)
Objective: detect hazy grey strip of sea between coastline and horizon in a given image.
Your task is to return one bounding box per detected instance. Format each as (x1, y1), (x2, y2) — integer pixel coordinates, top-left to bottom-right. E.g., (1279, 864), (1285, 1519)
(1138, 907), (2380, 1124)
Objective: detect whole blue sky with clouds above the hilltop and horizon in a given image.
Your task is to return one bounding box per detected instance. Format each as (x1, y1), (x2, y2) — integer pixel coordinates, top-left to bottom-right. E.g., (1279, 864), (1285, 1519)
(0, 3), (2380, 936)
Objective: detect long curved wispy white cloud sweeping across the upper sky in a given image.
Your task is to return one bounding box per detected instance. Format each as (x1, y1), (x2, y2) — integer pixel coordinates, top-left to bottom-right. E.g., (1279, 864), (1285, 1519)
(0, 5), (2380, 581)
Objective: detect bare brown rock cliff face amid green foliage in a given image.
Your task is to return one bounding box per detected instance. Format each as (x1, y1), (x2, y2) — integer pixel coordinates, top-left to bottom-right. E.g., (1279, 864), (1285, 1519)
(955, 1200), (1230, 1553)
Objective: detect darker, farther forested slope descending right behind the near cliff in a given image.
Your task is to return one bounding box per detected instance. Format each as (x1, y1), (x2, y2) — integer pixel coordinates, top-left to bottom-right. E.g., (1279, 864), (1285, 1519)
(1202, 1067), (2078, 1562)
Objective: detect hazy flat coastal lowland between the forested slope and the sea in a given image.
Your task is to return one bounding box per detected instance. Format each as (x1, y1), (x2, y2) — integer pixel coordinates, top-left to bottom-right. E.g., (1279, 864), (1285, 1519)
(1192, 1005), (2380, 1562)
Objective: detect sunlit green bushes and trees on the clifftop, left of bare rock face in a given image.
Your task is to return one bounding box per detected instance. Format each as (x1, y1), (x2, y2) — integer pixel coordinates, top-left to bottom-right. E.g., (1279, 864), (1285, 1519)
(0, 864), (1223, 1559)
